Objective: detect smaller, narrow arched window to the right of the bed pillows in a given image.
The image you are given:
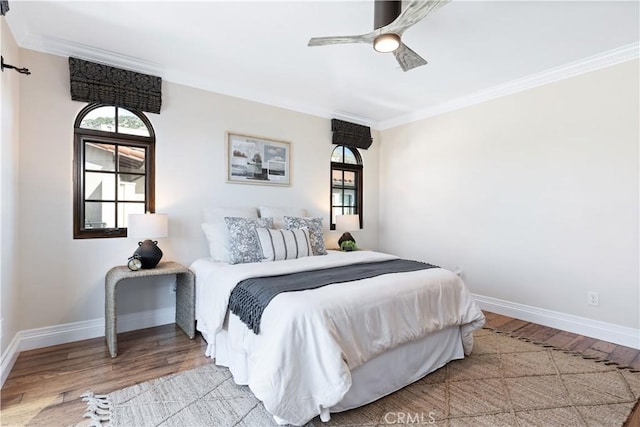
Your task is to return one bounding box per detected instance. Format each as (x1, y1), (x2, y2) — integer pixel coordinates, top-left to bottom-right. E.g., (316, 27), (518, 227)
(330, 145), (362, 230)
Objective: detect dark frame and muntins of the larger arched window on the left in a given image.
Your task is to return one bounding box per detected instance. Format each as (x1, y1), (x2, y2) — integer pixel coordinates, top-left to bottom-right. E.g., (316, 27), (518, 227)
(73, 103), (156, 239)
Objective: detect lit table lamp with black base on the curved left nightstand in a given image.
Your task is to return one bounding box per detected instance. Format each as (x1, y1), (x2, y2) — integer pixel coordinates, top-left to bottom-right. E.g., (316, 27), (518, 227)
(128, 213), (169, 268)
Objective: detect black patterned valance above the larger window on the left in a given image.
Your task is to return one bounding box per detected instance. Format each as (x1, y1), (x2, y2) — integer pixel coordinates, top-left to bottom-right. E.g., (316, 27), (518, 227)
(69, 58), (162, 113)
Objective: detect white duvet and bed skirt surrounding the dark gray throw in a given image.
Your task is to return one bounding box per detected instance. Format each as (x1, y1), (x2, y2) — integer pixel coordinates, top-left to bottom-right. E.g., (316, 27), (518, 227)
(190, 207), (484, 425)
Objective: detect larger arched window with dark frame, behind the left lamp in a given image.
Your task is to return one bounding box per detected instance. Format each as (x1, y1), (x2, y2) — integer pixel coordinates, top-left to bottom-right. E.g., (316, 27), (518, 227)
(73, 104), (155, 239)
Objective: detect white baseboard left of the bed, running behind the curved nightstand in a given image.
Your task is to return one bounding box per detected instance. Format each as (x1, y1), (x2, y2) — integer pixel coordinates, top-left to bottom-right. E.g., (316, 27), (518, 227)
(0, 307), (176, 386)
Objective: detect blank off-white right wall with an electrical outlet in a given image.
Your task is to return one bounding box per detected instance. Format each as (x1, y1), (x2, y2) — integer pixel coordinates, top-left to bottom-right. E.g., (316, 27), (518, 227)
(379, 60), (640, 330)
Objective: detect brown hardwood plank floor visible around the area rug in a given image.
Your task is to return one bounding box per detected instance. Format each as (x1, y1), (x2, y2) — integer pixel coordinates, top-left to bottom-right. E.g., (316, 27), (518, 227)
(0, 312), (640, 426)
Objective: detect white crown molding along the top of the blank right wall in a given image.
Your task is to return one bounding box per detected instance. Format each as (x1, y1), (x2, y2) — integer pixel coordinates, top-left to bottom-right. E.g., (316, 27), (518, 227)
(377, 42), (640, 130)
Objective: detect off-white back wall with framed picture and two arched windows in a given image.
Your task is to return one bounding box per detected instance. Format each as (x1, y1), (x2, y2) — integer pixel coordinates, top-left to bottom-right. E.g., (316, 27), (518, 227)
(18, 50), (378, 330)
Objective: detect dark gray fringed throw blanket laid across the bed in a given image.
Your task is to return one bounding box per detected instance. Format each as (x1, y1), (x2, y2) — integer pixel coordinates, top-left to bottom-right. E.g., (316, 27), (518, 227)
(229, 259), (437, 334)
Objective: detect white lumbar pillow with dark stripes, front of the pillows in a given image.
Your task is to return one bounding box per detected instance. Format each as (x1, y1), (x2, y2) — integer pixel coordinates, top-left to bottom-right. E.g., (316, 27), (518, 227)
(256, 228), (313, 261)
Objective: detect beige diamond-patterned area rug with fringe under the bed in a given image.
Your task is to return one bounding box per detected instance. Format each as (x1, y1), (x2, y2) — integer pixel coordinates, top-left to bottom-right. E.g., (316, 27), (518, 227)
(84, 329), (640, 427)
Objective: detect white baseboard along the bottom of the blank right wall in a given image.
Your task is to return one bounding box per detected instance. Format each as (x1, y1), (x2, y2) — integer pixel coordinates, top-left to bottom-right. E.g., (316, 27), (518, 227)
(473, 294), (640, 350)
